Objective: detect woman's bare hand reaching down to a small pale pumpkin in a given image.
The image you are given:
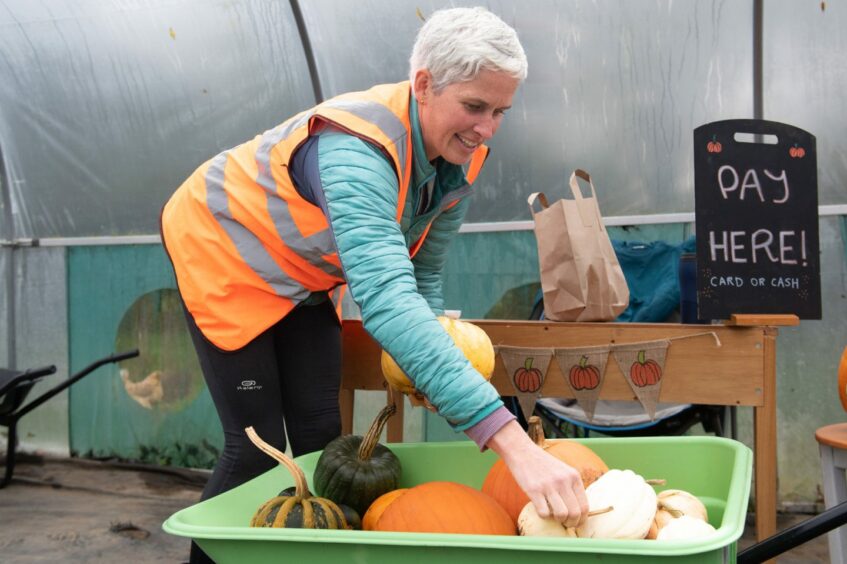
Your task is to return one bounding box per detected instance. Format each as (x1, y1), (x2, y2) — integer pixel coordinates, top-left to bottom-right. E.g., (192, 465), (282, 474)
(487, 421), (588, 527)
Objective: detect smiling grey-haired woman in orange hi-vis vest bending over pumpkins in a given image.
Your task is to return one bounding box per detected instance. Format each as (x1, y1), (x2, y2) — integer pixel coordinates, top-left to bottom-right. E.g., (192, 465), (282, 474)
(162, 8), (587, 556)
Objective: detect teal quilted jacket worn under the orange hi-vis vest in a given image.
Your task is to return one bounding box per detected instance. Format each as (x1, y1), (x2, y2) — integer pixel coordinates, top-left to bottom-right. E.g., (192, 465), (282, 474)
(317, 98), (503, 431)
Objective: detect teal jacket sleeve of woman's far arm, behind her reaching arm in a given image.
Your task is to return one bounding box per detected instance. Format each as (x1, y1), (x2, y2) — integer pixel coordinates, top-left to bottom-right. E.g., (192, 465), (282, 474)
(412, 198), (468, 315)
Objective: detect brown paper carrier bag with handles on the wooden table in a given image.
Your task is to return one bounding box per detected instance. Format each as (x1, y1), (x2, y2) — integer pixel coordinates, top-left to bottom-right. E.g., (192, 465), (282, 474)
(528, 170), (629, 321)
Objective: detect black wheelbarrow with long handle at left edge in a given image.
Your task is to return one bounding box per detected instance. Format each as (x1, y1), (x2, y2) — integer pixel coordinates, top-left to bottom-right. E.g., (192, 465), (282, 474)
(0, 349), (138, 489)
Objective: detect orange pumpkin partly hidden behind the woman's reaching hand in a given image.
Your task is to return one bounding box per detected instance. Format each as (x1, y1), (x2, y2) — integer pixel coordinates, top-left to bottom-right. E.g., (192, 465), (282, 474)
(482, 415), (609, 524)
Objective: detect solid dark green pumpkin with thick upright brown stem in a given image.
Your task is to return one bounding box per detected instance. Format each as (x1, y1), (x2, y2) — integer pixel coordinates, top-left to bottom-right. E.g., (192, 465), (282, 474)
(312, 404), (400, 515)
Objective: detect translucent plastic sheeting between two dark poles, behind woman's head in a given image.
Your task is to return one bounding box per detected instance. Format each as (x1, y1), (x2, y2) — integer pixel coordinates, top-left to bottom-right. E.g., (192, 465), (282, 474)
(301, 0), (753, 222)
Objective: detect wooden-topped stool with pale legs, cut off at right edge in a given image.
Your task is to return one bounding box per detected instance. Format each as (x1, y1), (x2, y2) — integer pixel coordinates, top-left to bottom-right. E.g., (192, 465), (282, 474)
(815, 423), (847, 562)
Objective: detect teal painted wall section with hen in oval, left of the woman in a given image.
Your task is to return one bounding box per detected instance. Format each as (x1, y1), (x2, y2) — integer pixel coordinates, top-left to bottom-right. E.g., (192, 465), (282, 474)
(68, 245), (223, 467)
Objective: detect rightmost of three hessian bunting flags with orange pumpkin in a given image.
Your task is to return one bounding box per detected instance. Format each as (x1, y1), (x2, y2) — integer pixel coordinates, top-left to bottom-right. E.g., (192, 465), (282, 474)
(612, 339), (671, 420)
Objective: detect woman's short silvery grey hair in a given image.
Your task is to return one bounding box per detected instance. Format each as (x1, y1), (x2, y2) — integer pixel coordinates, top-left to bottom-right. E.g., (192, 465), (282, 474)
(409, 7), (527, 93)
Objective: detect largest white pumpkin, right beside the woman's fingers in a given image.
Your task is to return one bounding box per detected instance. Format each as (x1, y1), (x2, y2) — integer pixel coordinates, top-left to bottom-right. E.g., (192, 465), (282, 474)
(576, 464), (656, 539)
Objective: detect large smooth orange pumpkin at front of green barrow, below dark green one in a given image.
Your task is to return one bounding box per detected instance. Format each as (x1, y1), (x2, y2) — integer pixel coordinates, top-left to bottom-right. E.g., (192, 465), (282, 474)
(368, 482), (515, 535)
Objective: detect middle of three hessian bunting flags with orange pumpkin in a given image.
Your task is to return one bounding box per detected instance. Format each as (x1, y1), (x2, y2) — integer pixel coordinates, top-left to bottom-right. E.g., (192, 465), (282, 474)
(554, 345), (610, 423)
